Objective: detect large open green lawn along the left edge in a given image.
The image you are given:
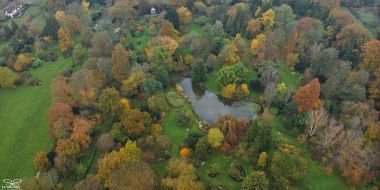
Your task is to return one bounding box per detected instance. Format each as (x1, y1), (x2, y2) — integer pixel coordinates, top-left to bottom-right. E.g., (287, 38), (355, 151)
(0, 57), (72, 179)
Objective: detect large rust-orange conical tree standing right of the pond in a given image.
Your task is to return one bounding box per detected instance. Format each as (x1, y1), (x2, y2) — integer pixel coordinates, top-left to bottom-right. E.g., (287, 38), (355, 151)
(293, 78), (321, 112)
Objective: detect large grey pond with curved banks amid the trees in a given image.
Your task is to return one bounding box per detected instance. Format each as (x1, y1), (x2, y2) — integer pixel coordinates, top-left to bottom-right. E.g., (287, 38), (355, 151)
(179, 78), (260, 123)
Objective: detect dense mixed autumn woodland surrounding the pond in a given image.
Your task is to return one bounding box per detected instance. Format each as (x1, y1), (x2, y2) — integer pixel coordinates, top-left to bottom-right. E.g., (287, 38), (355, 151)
(7, 0), (380, 189)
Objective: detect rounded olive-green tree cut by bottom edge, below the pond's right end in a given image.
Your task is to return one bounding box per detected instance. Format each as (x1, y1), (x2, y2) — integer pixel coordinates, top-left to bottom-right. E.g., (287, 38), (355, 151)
(242, 171), (269, 190)
